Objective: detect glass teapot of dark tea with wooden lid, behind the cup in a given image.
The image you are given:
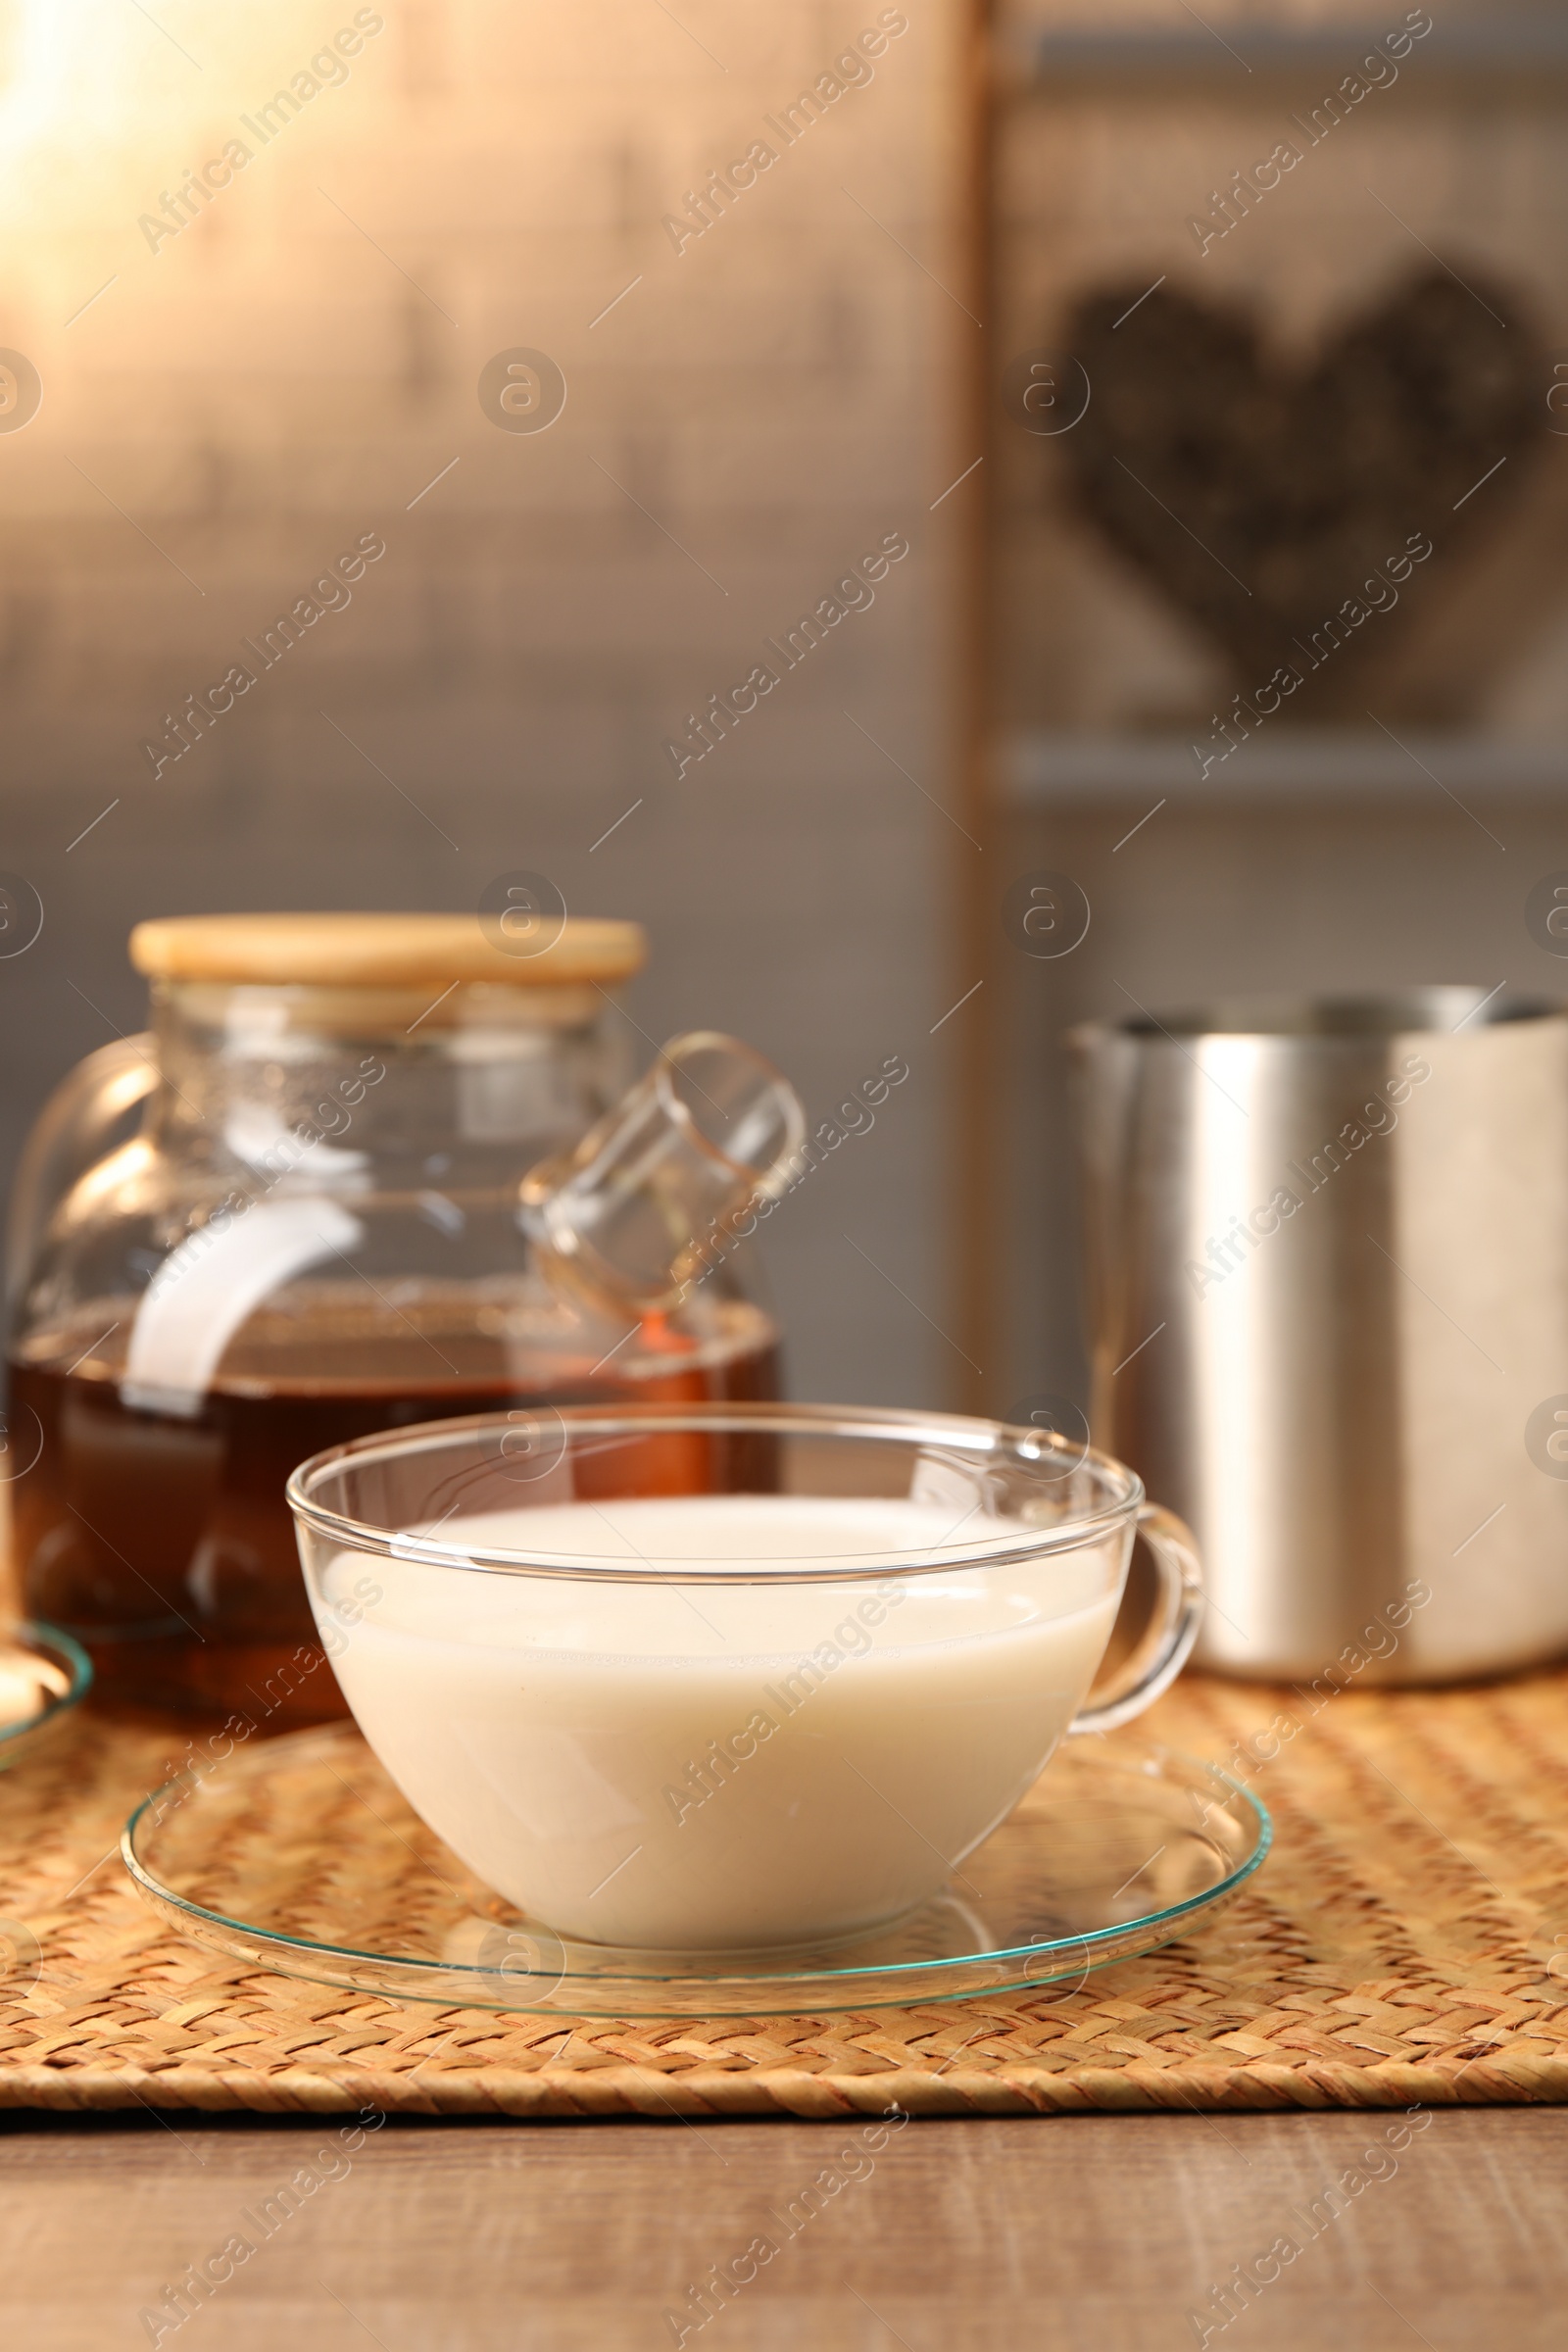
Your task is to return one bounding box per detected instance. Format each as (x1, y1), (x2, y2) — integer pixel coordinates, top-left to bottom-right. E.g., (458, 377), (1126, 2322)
(10, 915), (802, 1731)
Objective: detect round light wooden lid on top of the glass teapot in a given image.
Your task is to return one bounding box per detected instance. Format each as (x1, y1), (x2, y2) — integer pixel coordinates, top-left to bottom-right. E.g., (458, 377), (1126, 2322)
(129, 915), (647, 988)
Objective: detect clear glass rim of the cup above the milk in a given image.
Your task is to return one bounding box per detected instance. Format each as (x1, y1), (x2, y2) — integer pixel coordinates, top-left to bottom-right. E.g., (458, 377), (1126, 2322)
(287, 1404), (1145, 1586)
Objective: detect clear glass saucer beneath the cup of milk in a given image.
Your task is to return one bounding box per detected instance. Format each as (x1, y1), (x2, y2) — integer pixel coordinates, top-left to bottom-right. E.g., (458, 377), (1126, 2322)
(120, 1724), (1272, 2018)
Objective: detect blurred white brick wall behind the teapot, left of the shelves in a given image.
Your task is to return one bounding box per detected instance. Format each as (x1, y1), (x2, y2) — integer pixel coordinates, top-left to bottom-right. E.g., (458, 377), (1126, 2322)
(0, 0), (973, 1399)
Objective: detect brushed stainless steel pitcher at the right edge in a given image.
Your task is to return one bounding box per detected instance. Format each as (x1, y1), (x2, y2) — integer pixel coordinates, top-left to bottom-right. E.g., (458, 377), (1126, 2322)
(1069, 988), (1568, 1693)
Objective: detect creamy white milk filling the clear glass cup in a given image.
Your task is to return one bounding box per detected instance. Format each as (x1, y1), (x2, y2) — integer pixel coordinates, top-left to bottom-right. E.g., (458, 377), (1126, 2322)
(313, 1495), (1126, 1952)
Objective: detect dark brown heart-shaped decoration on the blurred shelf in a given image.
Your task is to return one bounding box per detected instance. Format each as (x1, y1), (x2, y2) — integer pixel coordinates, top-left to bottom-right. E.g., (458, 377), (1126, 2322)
(1060, 270), (1546, 717)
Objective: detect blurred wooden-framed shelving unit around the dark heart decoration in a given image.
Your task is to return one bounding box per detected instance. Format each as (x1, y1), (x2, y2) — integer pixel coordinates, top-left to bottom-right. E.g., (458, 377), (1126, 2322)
(958, 0), (1568, 1411)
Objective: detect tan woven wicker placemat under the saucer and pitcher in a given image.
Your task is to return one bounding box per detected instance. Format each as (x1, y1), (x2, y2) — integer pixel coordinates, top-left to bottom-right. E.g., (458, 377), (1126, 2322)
(0, 1672), (1568, 2119)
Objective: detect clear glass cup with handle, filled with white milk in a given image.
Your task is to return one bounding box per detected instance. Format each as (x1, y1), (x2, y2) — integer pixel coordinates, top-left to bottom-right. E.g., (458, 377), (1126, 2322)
(289, 1404), (1201, 1954)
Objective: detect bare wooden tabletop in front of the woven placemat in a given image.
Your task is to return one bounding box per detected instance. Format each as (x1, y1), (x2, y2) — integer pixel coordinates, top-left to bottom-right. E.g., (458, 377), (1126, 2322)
(0, 2107), (1568, 2352)
